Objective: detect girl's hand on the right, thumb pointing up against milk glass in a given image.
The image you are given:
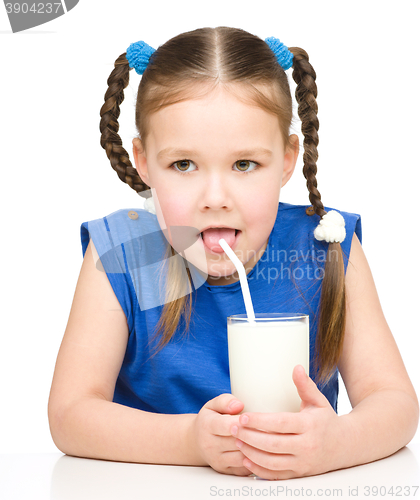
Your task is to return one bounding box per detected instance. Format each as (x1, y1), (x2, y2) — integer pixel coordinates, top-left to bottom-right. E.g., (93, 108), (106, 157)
(231, 365), (341, 479)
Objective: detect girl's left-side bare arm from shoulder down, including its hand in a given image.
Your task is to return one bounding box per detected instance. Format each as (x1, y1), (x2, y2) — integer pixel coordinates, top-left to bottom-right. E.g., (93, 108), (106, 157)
(48, 241), (249, 475)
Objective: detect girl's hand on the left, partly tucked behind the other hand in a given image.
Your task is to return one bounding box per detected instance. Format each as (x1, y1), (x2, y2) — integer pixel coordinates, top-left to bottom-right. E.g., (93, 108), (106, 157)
(193, 394), (251, 476)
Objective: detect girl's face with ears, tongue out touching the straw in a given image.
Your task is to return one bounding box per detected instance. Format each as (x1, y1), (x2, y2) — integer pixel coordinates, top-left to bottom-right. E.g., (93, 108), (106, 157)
(133, 86), (299, 285)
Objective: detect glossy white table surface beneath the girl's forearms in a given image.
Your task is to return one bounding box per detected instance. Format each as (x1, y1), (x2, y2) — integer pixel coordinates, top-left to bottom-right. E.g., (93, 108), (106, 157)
(0, 443), (420, 500)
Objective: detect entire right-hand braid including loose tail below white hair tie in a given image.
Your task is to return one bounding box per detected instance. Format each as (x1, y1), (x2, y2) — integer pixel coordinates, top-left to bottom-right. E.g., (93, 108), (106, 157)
(289, 47), (346, 383)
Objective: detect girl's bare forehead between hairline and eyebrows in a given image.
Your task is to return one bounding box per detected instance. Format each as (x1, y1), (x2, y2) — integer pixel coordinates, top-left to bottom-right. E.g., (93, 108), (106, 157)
(147, 86), (282, 154)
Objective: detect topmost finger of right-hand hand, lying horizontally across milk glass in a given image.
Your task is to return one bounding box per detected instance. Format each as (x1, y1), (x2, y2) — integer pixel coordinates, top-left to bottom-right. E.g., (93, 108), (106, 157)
(239, 412), (306, 434)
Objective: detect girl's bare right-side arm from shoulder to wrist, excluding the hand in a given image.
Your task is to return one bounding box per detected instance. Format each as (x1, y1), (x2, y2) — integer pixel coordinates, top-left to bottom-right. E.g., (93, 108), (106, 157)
(339, 236), (419, 466)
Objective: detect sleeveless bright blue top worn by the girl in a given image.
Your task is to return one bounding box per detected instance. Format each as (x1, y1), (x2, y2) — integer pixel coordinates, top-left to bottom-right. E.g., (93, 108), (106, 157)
(81, 203), (361, 414)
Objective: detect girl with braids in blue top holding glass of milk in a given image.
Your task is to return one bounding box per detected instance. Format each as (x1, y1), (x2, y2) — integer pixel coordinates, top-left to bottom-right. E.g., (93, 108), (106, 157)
(49, 27), (418, 479)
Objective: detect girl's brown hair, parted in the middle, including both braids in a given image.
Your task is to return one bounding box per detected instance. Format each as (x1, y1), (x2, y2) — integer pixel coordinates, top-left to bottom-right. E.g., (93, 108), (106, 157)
(100, 27), (345, 382)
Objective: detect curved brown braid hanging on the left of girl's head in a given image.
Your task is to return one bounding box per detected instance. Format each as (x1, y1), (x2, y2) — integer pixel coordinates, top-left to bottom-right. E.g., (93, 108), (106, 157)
(99, 53), (150, 193)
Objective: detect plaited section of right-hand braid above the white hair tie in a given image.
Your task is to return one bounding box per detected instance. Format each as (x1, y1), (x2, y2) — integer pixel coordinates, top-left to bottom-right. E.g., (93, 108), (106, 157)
(289, 47), (325, 217)
